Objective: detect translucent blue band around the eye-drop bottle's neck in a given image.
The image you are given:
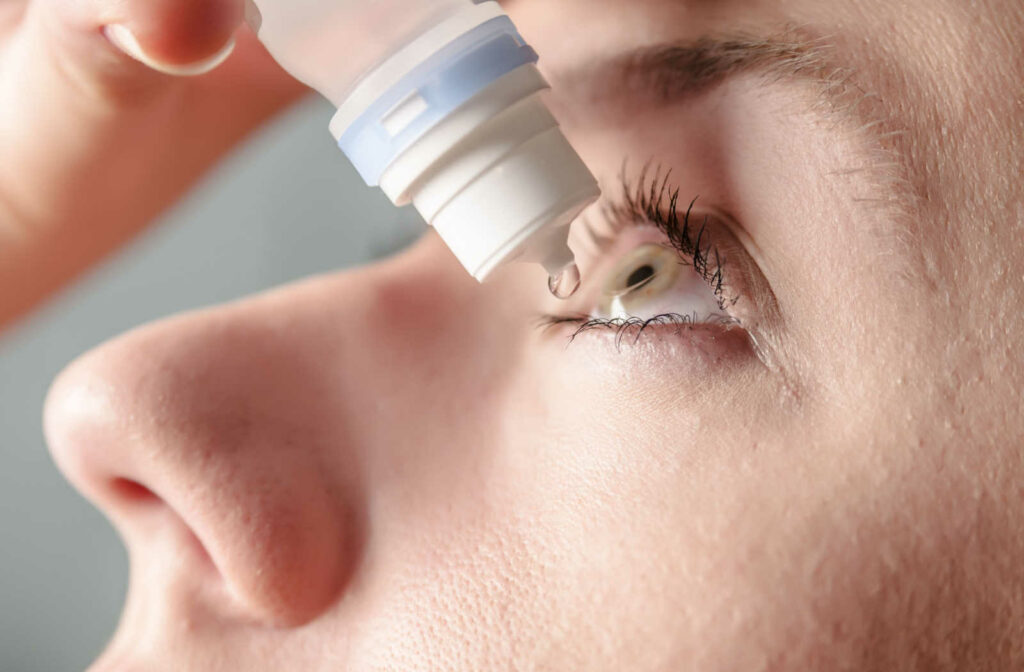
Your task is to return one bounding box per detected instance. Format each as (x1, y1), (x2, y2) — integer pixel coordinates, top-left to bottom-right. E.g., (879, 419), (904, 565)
(338, 16), (538, 186)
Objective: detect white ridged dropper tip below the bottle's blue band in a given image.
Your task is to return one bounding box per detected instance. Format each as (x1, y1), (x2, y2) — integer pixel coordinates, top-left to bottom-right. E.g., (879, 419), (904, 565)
(381, 66), (600, 282)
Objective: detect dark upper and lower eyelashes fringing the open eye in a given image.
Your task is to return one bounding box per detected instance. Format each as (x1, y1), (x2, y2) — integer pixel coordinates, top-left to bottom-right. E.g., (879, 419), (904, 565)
(542, 166), (738, 346)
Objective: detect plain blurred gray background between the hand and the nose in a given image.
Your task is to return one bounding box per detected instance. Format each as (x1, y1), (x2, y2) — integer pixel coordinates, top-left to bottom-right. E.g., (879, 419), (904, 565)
(0, 99), (423, 672)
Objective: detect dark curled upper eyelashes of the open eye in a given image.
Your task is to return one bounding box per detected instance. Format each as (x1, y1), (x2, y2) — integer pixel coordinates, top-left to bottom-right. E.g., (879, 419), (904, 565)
(603, 164), (738, 310)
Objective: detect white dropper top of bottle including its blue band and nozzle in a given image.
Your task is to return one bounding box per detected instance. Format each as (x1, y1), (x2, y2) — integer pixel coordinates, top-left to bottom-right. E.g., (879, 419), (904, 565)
(331, 2), (600, 282)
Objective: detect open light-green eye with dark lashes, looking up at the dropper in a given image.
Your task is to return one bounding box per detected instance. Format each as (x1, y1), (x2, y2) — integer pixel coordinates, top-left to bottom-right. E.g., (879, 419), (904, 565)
(542, 168), (748, 346)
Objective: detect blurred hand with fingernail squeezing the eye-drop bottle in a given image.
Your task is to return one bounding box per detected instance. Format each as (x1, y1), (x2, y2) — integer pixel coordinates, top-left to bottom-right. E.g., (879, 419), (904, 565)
(0, 0), (304, 327)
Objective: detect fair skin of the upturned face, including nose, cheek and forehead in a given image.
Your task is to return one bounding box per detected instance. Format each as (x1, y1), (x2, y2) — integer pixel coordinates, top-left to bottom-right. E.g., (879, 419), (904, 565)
(46, 0), (1024, 671)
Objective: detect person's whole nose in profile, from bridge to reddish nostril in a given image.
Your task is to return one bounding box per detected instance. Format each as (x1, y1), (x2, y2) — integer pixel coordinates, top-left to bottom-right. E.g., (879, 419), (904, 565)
(45, 234), (483, 626)
